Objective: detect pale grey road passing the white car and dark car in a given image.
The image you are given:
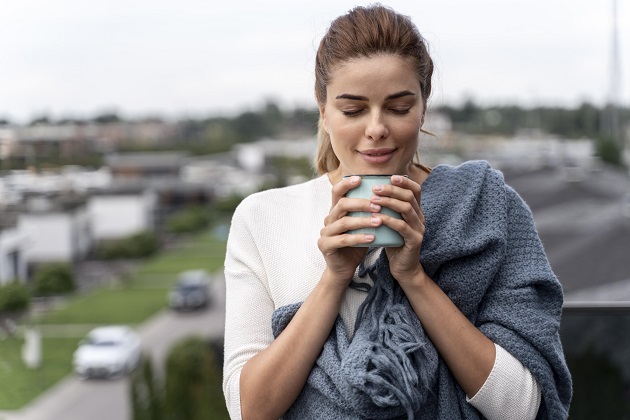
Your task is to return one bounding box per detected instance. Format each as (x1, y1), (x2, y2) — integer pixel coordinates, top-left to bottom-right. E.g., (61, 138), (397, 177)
(0, 277), (225, 420)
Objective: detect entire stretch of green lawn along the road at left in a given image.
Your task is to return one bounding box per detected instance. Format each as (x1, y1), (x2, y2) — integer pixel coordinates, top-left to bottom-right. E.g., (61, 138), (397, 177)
(0, 228), (230, 410)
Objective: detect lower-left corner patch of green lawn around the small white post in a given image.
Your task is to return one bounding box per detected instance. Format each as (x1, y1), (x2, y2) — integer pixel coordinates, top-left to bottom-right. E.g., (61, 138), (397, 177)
(0, 337), (79, 410)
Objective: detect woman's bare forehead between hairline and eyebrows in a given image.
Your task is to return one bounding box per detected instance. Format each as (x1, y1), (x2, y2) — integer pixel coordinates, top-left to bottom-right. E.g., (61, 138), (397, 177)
(326, 54), (420, 98)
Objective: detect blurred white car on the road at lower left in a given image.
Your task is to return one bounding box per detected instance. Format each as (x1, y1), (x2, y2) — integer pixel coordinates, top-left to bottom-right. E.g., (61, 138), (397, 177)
(72, 325), (142, 379)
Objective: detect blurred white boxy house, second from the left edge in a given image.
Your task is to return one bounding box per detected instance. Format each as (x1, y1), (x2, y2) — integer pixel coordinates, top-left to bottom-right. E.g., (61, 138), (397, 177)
(18, 194), (93, 264)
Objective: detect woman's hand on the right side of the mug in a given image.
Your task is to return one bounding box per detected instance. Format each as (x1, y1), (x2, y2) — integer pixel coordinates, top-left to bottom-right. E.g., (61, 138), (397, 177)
(370, 175), (425, 283)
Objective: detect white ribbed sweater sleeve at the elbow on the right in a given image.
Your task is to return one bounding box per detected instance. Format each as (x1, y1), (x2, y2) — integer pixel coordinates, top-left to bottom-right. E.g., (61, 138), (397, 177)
(467, 344), (541, 420)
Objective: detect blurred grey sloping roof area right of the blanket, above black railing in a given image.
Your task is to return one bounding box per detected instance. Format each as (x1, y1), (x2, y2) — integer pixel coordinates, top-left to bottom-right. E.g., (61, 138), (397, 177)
(506, 168), (630, 300)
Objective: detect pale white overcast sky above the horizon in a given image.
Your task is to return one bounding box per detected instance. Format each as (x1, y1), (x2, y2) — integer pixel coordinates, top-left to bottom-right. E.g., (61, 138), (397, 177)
(0, 0), (630, 122)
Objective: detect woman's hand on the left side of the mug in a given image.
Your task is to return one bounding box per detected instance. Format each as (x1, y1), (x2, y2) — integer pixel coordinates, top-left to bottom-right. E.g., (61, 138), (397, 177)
(317, 176), (382, 286)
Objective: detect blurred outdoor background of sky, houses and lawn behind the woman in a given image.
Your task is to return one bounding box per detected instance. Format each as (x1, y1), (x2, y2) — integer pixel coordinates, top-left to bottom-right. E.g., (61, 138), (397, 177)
(0, 0), (630, 420)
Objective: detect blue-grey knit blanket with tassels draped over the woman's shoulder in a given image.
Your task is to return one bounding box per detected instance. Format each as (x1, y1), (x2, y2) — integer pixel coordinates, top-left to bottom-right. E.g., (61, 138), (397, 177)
(272, 161), (571, 420)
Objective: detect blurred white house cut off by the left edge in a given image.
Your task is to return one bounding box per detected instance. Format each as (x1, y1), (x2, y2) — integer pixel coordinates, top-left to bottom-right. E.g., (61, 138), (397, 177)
(0, 208), (26, 285)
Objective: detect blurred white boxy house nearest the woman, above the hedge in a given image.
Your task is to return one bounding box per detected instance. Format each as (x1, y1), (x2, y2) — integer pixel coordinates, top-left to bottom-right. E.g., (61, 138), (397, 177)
(87, 185), (157, 241)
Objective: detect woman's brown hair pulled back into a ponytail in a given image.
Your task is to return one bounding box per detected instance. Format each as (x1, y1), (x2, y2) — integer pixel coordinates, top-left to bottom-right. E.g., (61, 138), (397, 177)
(315, 4), (433, 175)
